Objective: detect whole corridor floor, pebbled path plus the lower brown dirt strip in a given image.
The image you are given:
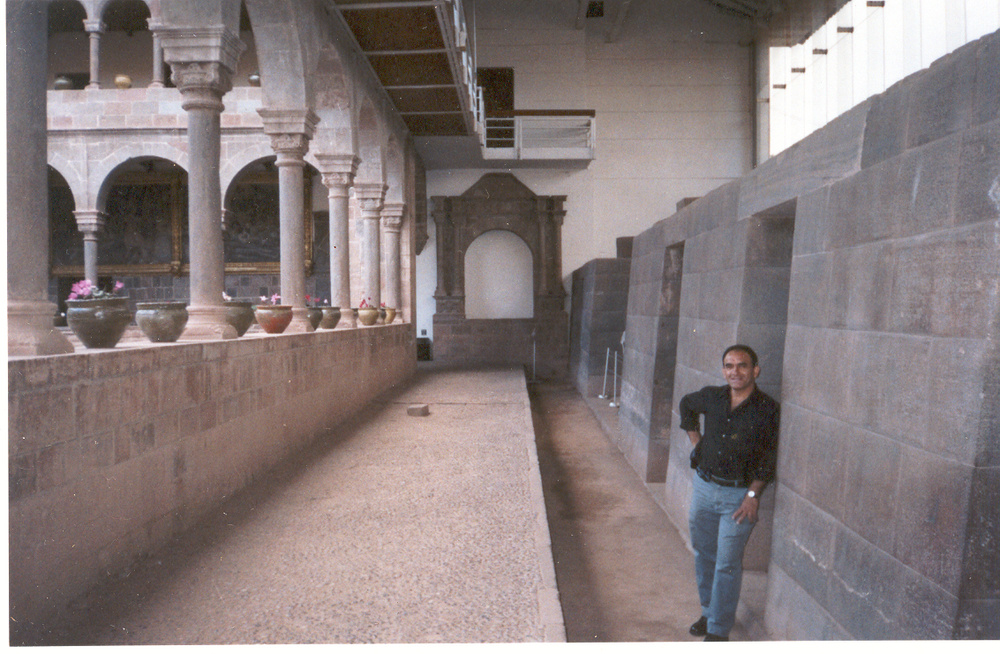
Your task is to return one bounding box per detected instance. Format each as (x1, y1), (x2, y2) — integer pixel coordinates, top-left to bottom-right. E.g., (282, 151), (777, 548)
(11, 367), (740, 645)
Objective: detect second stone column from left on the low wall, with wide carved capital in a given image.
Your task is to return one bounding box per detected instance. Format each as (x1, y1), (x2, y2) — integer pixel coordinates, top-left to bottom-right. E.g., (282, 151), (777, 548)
(160, 27), (245, 340)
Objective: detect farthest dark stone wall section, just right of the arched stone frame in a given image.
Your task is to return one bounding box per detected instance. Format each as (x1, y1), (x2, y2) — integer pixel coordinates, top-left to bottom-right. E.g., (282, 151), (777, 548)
(569, 259), (631, 396)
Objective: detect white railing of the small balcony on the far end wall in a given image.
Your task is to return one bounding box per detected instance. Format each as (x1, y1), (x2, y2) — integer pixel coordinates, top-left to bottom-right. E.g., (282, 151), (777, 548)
(483, 111), (595, 160)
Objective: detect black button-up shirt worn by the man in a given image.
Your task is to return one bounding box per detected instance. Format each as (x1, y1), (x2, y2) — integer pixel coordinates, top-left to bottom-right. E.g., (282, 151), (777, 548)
(680, 386), (779, 485)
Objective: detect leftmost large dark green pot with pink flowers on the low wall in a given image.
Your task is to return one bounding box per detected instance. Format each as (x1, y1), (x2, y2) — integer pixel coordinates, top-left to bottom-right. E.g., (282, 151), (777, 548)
(66, 279), (132, 348)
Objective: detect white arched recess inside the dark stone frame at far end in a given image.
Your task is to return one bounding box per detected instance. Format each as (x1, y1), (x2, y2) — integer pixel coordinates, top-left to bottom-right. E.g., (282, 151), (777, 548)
(463, 229), (536, 319)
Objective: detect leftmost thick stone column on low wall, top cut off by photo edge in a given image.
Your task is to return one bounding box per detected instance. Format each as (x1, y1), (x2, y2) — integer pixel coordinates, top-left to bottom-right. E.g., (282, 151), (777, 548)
(6, 2), (73, 356)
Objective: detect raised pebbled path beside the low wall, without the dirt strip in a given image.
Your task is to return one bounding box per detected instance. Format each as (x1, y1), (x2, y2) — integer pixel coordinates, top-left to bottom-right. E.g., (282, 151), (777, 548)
(12, 369), (564, 645)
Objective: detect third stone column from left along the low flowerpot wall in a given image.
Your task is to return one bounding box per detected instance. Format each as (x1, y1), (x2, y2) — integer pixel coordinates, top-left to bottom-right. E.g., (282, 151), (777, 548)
(257, 109), (319, 333)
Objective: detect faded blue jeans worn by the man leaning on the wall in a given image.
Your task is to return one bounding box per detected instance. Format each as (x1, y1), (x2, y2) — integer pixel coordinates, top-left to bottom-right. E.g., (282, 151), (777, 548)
(688, 474), (754, 636)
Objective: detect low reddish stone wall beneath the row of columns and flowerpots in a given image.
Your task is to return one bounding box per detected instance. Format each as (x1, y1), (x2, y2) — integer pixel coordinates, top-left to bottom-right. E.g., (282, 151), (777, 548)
(8, 324), (416, 621)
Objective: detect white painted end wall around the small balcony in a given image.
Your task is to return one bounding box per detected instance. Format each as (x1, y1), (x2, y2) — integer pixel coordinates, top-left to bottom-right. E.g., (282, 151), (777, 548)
(417, 0), (752, 335)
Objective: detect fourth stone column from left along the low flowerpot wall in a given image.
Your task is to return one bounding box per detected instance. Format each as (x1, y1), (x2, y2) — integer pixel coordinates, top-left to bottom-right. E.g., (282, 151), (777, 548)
(316, 154), (359, 328)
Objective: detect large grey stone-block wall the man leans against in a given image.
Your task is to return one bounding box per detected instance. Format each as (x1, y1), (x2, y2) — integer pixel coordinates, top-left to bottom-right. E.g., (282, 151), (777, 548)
(620, 33), (1000, 639)
